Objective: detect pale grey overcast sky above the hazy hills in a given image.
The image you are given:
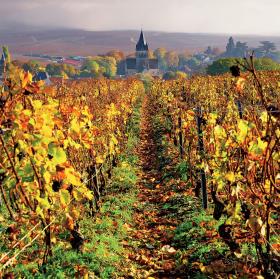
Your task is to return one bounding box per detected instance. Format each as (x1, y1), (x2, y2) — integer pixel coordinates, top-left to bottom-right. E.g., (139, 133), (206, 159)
(0, 0), (280, 35)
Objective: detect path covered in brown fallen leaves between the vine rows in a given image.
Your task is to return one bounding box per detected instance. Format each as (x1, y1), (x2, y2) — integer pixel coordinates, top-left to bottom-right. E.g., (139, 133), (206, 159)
(125, 95), (188, 279)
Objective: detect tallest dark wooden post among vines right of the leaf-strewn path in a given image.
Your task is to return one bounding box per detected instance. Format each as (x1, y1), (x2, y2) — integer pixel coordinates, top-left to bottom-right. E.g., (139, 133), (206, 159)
(196, 107), (208, 209)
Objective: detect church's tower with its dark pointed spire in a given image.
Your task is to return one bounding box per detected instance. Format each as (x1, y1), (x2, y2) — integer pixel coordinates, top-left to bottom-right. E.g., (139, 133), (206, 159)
(136, 30), (149, 72)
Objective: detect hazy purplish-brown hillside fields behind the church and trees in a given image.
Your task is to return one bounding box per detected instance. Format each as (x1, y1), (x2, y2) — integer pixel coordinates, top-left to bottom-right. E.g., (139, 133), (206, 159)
(0, 29), (280, 56)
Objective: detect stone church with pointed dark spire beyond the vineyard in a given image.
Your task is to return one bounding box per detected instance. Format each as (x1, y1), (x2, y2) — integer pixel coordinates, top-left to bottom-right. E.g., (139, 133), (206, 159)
(125, 30), (159, 76)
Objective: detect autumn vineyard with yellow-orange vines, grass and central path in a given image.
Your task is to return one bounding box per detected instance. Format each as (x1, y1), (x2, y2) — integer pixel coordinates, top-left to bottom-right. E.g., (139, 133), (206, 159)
(0, 60), (280, 279)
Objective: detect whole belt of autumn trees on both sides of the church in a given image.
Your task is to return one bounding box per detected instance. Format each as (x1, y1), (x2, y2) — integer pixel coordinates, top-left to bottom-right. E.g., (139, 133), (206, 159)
(0, 37), (280, 79)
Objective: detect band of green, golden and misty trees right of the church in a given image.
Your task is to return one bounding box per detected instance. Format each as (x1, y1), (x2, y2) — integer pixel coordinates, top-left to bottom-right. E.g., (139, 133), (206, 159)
(153, 37), (280, 77)
